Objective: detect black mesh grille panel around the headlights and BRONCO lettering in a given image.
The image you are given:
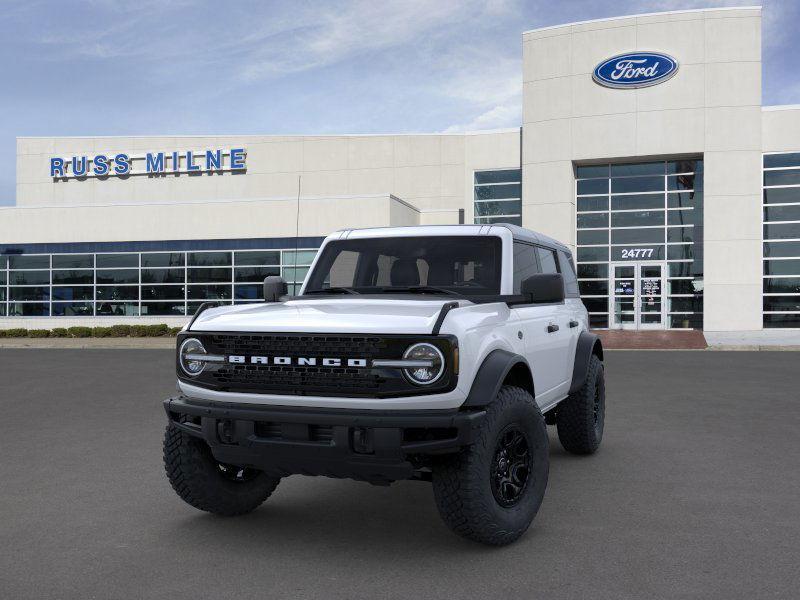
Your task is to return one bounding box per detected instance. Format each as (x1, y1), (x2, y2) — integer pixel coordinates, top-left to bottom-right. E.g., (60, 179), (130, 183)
(178, 332), (455, 398)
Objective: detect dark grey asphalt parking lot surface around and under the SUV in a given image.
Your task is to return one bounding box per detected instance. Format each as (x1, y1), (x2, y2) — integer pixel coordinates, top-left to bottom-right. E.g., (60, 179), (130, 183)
(0, 349), (800, 600)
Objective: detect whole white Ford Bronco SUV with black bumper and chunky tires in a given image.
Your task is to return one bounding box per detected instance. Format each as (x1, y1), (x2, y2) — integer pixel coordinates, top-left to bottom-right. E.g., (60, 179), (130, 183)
(164, 224), (605, 545)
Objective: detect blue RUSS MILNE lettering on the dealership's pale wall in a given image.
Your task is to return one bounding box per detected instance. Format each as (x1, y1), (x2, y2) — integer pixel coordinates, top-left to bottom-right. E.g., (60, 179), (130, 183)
(50, 148), (247, 179)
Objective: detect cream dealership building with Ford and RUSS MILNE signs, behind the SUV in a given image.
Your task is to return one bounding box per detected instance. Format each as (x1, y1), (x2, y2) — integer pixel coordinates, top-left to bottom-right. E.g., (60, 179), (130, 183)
(0, 7), (800, 335)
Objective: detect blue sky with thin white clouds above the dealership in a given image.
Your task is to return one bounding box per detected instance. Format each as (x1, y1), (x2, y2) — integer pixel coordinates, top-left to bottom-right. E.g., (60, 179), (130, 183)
(0, 0), (800, 205)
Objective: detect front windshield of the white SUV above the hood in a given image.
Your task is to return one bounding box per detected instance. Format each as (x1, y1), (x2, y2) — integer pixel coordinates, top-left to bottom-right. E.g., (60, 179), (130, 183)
(304, 236), (502, 296)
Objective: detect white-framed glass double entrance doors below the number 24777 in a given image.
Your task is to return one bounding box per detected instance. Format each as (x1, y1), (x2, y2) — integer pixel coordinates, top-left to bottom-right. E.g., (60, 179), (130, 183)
(610, 262), (666, 329)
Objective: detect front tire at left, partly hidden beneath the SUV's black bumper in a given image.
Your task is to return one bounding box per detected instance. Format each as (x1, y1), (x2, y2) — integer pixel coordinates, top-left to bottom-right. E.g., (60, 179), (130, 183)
(164, 424), (280, 517)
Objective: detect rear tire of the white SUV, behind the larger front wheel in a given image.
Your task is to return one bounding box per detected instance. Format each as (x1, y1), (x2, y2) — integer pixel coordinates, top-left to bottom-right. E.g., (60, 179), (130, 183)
(556, 354), (606, 454)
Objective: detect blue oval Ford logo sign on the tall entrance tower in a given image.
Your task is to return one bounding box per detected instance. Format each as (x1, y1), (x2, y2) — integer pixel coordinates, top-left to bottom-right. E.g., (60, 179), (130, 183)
(592, 52), (678, 88)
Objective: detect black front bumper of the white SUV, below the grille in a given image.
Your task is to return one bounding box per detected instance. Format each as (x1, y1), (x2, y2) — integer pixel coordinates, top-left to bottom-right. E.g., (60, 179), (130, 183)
(164, 396), (486, 483)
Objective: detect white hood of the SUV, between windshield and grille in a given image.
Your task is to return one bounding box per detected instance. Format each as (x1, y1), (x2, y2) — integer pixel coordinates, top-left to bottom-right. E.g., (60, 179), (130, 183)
(192, 297), (462, 334)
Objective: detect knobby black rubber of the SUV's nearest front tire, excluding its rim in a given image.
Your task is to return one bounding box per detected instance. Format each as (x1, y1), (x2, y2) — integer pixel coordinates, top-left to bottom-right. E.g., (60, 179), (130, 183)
(432, 386), (550, 546)
